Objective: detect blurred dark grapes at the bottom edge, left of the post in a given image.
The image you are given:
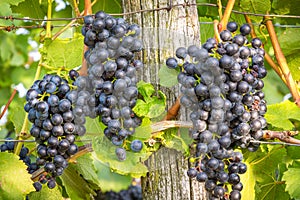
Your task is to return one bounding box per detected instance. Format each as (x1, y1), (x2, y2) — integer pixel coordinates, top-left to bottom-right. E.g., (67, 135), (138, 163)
(103, 185), (143, 200)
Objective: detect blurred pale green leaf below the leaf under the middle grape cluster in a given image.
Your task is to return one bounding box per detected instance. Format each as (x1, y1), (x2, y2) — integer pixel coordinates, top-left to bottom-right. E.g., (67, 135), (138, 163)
(93, 158), (132, 192)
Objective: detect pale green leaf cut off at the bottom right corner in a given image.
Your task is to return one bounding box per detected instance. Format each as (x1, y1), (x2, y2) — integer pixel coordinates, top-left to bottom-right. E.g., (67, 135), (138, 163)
(282, 168), (300, 199)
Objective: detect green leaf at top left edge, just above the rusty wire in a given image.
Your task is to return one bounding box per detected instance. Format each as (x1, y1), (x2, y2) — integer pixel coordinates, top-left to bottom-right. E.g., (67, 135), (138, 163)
(11, 0), (47, 19)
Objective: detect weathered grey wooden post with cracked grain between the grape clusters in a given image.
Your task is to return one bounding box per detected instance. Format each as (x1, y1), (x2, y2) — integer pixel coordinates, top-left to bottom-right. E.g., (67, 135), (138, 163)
(122, 0), (206, 200)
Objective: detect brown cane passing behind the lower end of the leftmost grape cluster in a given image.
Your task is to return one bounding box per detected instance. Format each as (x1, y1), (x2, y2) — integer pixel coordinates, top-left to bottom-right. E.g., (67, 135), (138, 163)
(31, 144), (93, 181)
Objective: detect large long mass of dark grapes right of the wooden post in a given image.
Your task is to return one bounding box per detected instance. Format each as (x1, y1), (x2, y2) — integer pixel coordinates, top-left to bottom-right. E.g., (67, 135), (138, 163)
(166, 22), (267, 200)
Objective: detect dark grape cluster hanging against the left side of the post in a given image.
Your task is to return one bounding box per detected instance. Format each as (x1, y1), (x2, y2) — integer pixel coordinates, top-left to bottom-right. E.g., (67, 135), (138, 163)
(81, 11), (143, 161)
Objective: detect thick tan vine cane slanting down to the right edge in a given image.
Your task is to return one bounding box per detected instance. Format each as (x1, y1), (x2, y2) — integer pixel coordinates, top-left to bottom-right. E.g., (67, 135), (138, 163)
(264, 16), (300, 107)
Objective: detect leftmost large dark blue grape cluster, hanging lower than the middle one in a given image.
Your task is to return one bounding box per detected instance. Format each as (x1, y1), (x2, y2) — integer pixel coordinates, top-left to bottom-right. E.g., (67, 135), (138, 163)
(24, 71), (84, 190)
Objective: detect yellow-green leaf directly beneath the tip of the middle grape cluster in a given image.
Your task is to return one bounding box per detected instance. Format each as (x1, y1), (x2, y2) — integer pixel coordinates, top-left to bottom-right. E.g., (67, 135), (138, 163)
(93, 136), (151, 178)
